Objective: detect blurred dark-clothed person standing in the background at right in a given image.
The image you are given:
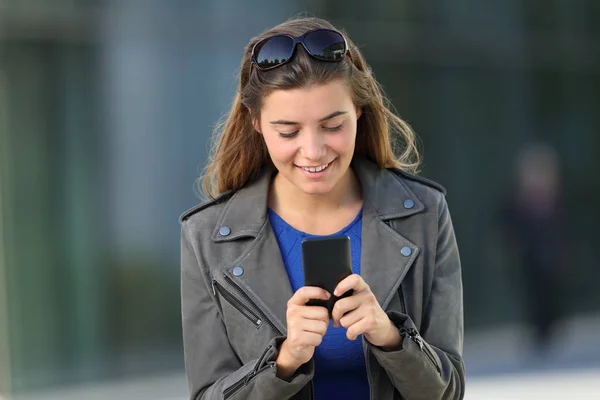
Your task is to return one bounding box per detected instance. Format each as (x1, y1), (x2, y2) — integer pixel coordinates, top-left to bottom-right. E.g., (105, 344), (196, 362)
(502, 142), (568, 350)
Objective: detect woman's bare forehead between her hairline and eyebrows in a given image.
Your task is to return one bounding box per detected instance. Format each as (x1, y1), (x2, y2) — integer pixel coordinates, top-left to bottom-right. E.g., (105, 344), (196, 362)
(261, 80), (352, 122)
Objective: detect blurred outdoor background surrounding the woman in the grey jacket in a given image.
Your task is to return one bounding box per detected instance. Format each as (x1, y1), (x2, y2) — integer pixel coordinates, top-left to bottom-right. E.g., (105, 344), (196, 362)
(0, 0), (600, 399)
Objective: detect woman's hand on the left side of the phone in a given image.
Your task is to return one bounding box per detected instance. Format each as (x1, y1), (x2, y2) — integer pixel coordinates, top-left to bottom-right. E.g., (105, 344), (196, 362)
(276, 286), (331, 378)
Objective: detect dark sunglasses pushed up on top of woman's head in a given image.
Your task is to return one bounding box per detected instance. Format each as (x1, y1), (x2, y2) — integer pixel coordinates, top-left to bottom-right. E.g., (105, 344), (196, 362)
(250, 29), (350, 73)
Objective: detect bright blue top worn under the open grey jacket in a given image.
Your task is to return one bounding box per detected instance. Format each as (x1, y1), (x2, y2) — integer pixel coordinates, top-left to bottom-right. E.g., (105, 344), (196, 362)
(268, 208), (370, 400)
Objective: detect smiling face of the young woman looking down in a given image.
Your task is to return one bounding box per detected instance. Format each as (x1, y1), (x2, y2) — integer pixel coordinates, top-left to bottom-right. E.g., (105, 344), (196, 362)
(257, 80), (361, 195)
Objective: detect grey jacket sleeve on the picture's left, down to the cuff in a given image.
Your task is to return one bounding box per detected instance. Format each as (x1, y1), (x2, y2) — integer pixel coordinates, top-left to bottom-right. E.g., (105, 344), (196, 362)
(181, 221), (314, 400)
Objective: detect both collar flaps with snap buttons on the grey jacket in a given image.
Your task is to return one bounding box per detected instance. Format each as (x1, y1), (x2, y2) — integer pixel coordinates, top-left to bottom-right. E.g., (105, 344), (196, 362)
(211, 157), (425, 242)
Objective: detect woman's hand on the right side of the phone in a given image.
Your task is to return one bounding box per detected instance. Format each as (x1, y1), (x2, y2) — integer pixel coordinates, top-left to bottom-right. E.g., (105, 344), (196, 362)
(332, 274), (401, 350)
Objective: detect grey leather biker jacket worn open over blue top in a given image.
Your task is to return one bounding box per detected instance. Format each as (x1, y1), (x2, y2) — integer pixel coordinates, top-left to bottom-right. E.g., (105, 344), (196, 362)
(181, 158), (465, 400)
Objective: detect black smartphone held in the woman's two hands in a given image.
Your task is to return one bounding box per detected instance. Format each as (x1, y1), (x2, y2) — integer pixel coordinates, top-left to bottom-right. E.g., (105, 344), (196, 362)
(302, 236), (353, 316)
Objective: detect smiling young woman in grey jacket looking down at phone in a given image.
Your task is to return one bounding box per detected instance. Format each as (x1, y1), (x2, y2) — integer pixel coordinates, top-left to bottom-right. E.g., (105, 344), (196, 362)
(181, 18), (464, 400)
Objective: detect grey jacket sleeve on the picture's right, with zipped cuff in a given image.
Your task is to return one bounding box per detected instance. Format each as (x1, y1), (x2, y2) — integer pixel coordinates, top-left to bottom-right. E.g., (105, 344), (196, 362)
(369, 197), (465, 400)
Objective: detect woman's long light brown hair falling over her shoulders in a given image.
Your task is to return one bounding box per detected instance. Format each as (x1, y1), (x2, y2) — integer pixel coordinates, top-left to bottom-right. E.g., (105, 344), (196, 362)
(202, 17), (420, 197)
